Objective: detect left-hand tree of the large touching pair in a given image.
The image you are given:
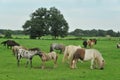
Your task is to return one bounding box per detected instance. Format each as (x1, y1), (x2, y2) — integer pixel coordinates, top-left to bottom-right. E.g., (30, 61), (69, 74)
(23, 8), (49, 39)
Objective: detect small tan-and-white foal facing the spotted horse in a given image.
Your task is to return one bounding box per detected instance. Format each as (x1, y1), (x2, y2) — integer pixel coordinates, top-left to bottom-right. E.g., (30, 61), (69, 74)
(40, 52), (58, 69)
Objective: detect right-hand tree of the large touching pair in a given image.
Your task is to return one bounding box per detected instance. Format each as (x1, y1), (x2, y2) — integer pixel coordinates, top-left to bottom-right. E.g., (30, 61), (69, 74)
(50, 7), (69, 38)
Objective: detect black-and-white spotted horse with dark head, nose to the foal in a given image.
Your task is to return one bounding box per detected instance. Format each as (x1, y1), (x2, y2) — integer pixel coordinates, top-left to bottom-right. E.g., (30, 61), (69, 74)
(17, 48), (41, 67)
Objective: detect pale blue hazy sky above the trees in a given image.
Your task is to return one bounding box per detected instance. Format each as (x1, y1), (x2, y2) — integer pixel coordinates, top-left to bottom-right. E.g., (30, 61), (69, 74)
(0, 0), (120, 32)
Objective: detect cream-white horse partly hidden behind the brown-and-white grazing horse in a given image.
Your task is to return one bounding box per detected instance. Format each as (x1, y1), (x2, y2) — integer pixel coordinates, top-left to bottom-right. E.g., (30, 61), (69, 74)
(62, 45), (81, 66)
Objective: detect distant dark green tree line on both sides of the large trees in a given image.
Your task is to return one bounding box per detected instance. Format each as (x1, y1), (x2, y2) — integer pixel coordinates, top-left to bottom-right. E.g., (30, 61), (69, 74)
(0, 29), (120, 38)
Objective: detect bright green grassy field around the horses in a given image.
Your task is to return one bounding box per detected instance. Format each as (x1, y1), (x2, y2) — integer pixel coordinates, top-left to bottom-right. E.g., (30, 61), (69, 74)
(0, 38), (120, 80)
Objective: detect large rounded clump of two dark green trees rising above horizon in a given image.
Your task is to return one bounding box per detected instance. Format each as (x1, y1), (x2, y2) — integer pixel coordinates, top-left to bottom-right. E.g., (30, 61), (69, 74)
(23, 7), (69, 39)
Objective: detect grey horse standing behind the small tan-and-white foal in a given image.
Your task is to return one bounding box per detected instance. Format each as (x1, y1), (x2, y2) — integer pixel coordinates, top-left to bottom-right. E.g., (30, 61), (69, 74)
(50, 43), (65, 53)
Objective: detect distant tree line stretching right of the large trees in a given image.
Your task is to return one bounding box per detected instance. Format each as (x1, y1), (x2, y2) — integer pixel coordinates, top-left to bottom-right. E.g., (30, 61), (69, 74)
(69, 29), (120, 37)
